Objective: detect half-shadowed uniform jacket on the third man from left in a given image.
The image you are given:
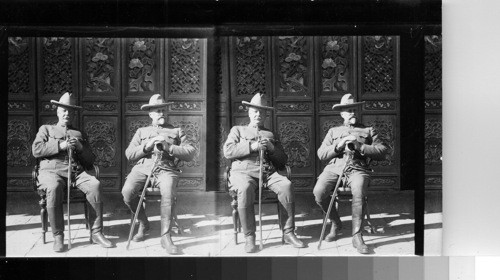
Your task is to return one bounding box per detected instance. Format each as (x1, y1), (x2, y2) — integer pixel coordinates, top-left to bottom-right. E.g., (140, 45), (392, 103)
(224, 126), (288, 174)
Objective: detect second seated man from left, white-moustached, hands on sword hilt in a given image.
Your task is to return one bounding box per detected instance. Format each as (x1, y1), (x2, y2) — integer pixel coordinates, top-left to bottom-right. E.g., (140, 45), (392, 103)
(122, 94), (196, 255)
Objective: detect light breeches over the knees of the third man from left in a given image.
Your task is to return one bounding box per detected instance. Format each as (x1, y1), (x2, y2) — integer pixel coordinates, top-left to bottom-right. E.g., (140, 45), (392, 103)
(229, 172), (295, 208)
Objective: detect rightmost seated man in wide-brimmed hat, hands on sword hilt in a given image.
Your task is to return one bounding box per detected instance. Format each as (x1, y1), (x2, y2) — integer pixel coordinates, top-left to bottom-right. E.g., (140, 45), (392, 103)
(313, 94), (388, 254)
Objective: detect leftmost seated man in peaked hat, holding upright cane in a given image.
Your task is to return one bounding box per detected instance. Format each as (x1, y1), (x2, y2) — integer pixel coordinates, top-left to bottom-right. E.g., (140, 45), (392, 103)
(32, 92), (114, 252)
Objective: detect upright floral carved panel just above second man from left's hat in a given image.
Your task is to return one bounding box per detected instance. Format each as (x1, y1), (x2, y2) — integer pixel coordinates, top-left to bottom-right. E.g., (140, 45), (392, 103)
(127, 38), (158, 92)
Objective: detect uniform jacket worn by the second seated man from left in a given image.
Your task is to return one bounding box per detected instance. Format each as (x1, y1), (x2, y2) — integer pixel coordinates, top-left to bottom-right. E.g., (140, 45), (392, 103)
(125, 124), (196, 174)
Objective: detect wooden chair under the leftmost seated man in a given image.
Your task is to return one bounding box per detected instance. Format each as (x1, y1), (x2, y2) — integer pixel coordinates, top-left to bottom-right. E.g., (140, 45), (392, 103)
(31, 159), (99, 244)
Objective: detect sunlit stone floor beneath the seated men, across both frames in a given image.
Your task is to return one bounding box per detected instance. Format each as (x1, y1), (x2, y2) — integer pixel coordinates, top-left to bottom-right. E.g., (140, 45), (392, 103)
(6, 191), (442, 257)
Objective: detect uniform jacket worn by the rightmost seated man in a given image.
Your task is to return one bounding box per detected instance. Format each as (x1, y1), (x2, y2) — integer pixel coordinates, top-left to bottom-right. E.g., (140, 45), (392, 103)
(318, 124), (388, 175)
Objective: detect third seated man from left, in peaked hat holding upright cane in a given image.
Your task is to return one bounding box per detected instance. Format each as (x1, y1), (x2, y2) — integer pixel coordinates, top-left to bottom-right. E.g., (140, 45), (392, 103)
(224, 93), (304, 253)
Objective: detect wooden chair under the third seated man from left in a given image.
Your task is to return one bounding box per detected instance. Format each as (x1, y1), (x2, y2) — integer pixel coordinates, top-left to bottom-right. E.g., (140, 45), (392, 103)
(224, 164), (291, 244)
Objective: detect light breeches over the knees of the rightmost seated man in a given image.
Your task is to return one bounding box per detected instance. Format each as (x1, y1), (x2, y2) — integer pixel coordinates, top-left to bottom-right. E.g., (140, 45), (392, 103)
(313, 170), (370, 206)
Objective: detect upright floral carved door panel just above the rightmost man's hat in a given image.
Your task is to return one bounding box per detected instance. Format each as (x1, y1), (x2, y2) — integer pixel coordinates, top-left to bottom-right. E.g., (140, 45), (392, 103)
(321, 36), (351, 92)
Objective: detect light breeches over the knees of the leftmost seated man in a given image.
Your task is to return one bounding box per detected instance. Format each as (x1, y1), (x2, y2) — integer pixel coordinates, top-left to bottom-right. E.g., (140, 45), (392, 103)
(38, 170), (102, 207)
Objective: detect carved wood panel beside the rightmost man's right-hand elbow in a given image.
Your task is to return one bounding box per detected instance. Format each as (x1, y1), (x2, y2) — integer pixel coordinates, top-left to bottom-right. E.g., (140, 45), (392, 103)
(366, 118), (396, 166)
